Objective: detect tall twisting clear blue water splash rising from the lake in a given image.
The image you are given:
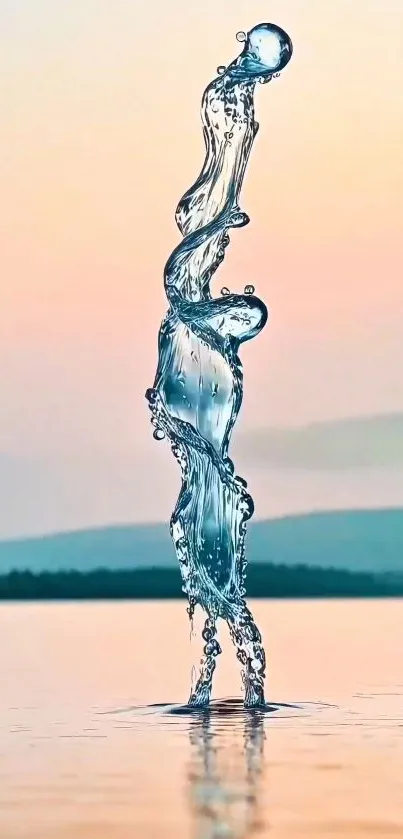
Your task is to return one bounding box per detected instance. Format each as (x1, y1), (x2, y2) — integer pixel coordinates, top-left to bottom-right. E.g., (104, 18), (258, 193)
(146, 23), (292, 707)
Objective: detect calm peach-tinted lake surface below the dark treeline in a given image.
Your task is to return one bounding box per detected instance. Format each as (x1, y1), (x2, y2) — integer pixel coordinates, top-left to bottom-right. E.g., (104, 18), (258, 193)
(0, 600), (403, 839)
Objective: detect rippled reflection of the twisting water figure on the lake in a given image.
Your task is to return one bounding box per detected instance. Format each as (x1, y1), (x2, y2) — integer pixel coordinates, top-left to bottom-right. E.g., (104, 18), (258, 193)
(188, 702), (266, 839)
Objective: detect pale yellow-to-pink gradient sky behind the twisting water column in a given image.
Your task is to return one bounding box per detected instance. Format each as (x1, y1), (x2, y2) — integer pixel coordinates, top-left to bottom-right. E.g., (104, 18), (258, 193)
(0, 0), (403, 534)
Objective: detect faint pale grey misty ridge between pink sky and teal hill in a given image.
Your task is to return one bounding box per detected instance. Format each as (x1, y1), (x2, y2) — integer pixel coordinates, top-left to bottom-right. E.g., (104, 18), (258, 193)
(0, 413), (403, 539)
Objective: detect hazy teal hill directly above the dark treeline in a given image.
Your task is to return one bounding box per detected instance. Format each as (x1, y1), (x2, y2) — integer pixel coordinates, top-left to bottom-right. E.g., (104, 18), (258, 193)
(0, 509), (403, 574)
